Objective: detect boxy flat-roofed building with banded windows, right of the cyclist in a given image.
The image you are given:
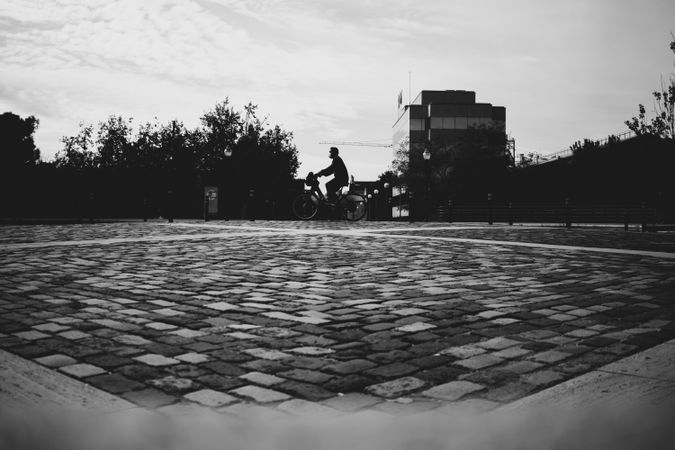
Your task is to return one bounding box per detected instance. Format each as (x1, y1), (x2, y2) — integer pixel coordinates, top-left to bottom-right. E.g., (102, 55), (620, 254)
(392, 90), (513, 216)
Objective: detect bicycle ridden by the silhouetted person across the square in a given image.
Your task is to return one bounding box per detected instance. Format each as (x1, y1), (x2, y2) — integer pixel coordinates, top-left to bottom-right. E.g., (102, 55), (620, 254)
(293, 172), (366, 222)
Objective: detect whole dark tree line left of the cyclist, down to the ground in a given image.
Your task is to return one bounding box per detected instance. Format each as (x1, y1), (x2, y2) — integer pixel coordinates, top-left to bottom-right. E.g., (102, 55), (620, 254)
(0, 98), (299, 220)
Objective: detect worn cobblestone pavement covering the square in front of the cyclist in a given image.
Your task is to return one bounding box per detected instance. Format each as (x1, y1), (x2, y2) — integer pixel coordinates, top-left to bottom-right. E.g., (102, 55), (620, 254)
(0, 221), (675, 414)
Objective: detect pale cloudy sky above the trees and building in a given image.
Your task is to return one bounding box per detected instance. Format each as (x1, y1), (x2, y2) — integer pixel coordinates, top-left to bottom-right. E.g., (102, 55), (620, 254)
(0, 0), (675, 180)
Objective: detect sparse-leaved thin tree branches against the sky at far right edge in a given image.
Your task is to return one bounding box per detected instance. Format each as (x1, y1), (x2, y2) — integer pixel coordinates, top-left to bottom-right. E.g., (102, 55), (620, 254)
(624, 36), (675, 139)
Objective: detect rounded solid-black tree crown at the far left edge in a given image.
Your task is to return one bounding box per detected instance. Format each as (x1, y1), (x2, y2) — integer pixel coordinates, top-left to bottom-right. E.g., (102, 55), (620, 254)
(0, 112), (40, 170)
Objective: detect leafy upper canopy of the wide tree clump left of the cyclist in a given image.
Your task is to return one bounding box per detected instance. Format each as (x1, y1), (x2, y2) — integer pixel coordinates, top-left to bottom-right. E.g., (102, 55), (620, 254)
(55, 98), (298, 185)
